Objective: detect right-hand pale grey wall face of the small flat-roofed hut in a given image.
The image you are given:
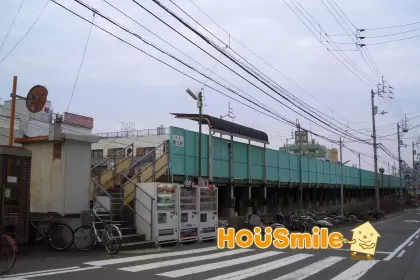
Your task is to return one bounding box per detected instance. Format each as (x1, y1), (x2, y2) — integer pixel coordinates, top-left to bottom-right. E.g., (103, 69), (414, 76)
(63, 140), (91, 214)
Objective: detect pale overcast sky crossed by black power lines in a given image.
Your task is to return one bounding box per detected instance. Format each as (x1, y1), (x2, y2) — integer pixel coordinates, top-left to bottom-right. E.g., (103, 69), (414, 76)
(0, 0), (420, 173)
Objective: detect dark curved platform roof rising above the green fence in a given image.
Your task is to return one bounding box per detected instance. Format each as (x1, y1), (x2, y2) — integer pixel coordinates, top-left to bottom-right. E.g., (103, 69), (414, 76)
(171, 113), (269, 144)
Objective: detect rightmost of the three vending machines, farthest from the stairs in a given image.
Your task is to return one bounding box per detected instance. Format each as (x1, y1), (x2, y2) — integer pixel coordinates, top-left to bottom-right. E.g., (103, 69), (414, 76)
(198, 185), (219, 241)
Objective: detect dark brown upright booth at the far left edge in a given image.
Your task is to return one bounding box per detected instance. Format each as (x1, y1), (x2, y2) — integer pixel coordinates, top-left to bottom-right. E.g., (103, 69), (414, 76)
(0, 146), (32, 244)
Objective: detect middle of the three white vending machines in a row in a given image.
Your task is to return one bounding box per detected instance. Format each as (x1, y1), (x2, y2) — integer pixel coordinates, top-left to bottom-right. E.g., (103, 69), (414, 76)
(178, 185), (198, 243)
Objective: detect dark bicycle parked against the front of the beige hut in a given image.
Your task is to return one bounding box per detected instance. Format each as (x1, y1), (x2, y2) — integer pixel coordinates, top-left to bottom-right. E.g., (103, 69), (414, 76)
(29, 213), (74, 251)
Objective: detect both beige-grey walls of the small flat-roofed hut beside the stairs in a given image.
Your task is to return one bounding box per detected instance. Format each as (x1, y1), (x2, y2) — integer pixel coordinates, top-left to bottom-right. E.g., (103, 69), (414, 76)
(24, 139), (91, 215)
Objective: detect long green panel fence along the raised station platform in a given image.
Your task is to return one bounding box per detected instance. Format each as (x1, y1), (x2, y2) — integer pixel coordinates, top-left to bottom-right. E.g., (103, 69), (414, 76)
(169, 127), (399, 188)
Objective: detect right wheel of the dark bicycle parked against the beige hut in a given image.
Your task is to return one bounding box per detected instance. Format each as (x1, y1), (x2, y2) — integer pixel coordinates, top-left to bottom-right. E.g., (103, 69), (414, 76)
(47, 223), (74, 251)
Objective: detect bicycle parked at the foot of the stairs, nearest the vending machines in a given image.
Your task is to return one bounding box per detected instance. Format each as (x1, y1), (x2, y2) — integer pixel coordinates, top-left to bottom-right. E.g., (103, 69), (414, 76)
(74, 206), (122, 255)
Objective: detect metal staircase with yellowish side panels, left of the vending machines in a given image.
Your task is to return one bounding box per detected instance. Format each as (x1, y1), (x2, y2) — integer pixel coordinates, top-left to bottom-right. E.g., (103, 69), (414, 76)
(90, 143), (168, 250)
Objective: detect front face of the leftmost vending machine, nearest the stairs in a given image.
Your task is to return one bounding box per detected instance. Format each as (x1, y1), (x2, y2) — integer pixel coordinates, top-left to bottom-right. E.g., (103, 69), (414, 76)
(155, 184), (178, 243)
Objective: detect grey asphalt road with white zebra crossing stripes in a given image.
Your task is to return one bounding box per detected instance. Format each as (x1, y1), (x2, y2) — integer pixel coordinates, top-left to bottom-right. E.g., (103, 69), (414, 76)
(6, 209), (420, 280)
